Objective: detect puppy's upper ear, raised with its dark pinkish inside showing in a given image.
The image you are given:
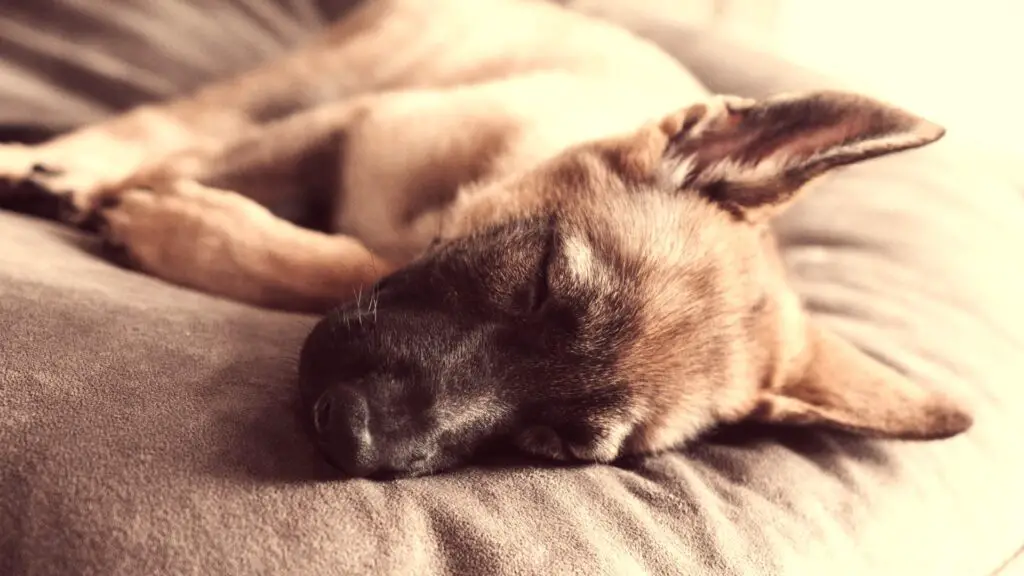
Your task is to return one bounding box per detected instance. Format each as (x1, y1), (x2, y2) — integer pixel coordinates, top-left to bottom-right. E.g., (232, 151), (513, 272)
(662, 91), (945, 221)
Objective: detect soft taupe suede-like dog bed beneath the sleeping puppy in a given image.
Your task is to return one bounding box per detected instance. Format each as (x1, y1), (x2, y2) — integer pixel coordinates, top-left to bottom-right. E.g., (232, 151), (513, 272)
(0, 0), (1024, 576)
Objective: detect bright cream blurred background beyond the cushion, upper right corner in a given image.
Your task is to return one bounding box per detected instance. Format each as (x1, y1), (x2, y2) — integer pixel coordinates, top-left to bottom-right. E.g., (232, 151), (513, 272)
(568, 0), (1024, 160)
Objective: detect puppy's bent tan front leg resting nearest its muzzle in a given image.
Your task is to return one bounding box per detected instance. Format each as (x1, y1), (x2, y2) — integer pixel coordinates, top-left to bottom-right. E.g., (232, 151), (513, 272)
(99, 180), (394, 313)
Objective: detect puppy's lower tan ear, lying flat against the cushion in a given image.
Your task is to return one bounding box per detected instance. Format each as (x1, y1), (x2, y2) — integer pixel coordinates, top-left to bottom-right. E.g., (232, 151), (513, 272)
(750, 328), (973, 440)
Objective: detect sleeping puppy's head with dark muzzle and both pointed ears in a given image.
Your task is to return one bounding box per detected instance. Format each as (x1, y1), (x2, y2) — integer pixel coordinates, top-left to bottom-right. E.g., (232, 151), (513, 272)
(301, 92), (971, 476)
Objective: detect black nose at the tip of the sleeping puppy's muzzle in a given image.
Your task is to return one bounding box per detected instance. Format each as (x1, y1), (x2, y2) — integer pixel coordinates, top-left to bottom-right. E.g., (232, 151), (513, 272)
(310, 387), (378, 478)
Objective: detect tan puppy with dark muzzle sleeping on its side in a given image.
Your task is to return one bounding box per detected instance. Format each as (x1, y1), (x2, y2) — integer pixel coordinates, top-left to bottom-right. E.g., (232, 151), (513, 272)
(0, 0), (972, 478)
